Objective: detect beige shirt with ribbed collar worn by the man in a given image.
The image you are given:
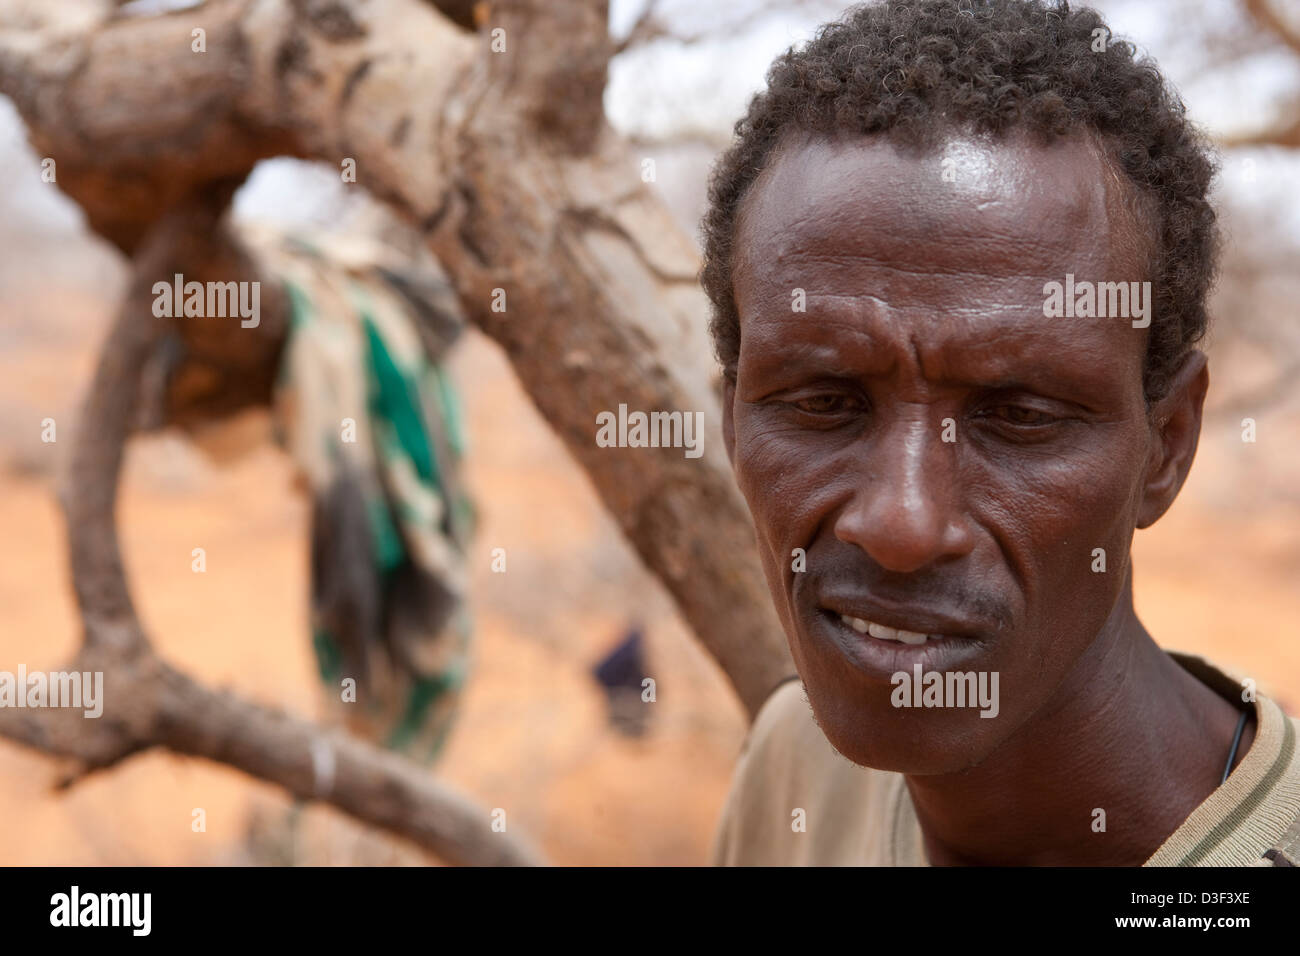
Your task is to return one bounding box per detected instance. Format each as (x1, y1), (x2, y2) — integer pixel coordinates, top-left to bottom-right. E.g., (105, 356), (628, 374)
(714, 653), (1300, 866)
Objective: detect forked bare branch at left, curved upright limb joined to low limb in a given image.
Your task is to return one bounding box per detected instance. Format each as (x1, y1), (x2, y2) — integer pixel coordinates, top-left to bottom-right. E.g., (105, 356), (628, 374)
(0, 195), (541, 865)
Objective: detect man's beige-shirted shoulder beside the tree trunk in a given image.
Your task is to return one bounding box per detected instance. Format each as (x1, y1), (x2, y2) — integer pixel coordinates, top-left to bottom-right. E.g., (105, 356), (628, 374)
(714, 679), (900, 866)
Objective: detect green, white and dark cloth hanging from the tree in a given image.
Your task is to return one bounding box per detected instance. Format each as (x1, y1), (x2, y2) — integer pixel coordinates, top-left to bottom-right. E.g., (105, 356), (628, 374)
(257, 227), (473, 762)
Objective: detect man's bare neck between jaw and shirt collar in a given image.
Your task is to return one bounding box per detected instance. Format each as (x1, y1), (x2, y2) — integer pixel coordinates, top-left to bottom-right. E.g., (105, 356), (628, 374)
(907, 579), (1255, 866)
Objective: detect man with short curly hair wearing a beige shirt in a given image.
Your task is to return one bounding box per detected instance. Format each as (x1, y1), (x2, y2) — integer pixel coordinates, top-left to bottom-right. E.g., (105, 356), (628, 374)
(703, 0), (1300, 865)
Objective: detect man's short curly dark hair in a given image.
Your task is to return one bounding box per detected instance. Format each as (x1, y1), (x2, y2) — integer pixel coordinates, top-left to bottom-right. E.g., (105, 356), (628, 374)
(701, 0), (1219, 402)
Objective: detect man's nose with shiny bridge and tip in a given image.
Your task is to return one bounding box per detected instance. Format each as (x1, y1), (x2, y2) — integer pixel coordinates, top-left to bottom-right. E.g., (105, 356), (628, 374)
(835, 419), (975, 574)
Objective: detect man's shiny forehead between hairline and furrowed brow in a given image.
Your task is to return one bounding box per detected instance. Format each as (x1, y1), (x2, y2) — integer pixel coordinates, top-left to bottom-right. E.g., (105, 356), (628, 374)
(735, 128), (1139, 299)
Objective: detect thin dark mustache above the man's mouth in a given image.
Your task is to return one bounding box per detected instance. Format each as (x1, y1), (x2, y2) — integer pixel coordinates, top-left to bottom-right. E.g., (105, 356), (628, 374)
(794, 549), (1013, 630)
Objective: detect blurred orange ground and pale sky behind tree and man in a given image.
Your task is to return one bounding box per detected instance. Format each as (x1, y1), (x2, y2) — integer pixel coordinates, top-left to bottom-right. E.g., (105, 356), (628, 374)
(0, 0), (1300, 865)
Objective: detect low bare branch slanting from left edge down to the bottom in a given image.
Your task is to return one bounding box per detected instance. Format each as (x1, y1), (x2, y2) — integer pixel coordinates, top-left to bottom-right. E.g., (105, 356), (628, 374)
(0, 646), (543, 866)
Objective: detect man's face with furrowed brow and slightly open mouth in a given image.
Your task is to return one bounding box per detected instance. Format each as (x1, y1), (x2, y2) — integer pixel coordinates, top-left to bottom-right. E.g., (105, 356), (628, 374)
(725, 130), (1152, 774)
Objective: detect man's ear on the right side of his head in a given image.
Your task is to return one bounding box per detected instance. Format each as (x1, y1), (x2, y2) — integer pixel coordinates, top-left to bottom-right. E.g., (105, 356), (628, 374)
(1138, 349), (1210, 528)
